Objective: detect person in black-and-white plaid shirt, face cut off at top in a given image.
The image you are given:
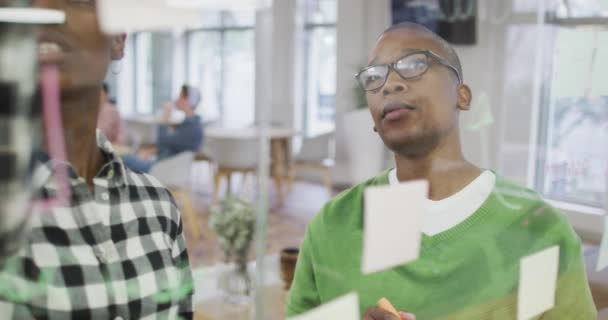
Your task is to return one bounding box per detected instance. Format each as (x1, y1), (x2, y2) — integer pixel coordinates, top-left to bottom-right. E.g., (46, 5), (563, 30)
(0, 0), (193, 319)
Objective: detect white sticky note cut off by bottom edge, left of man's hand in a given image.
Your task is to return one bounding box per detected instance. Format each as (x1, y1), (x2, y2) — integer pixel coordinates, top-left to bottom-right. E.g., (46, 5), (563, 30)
(288, 293), (361, 320)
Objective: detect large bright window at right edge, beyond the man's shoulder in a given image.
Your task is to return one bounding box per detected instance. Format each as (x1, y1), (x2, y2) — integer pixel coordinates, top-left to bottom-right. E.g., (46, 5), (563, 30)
(536, 28), (608, 207)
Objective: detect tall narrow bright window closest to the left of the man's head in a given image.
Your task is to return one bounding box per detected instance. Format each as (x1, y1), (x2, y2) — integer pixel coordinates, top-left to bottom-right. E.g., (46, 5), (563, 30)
(302, 0), (337, 135)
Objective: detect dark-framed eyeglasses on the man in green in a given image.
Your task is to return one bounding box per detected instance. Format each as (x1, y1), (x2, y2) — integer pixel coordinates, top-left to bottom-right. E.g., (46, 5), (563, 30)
(355, 50), (462, 91)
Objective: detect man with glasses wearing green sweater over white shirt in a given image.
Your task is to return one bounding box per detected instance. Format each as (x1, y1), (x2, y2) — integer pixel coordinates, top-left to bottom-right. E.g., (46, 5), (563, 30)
(287, 23), (596, 320)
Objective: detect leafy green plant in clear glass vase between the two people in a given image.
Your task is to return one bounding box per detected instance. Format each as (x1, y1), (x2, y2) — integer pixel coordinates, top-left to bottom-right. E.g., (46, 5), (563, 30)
(209, 196), (255, 303)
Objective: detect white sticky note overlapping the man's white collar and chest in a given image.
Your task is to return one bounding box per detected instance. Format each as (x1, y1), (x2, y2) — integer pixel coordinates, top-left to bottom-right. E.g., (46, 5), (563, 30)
(361, 180), (429, 274)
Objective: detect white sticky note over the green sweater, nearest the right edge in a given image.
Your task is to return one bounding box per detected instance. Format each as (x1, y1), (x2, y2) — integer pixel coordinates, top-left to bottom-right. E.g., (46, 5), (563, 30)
(517, 246), (559, 320)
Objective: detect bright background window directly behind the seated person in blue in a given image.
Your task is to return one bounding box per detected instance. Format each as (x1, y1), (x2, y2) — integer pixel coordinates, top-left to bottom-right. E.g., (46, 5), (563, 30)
(187, 12), (255, 127)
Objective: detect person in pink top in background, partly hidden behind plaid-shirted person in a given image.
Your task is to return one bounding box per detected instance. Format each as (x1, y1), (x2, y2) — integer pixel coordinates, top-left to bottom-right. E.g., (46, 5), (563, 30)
(97, 83), (126, 144)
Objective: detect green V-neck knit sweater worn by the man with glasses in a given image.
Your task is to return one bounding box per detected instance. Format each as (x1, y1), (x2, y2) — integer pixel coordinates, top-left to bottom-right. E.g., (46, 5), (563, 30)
(287, 171), (597, 320)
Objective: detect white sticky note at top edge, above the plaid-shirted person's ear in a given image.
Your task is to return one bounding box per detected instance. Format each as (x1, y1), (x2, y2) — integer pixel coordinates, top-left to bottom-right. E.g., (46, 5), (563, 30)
(97, 0), (202, 34)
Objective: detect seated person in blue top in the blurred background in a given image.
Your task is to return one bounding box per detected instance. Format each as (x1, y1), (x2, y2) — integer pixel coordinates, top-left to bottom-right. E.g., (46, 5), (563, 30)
(123, 85), (203, 172)
